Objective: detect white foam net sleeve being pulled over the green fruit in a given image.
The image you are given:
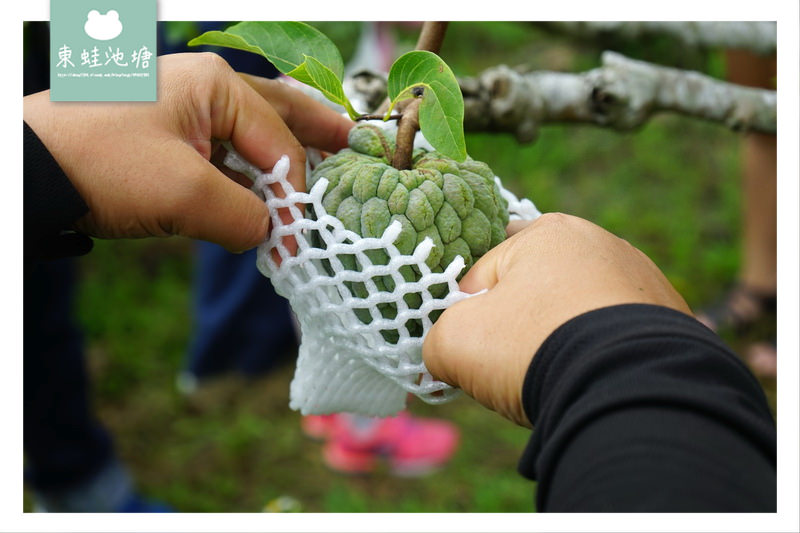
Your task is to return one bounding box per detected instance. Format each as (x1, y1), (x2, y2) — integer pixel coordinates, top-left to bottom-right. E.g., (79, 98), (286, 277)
(225, 128), (539, 416)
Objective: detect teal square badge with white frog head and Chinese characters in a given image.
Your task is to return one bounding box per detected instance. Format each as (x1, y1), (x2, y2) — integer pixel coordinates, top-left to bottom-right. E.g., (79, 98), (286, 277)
(50, 0), (157, 102)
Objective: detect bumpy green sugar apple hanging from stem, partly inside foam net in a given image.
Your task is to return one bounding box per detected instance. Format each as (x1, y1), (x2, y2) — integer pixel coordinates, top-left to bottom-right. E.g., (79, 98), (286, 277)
(307, 123), (508, 343)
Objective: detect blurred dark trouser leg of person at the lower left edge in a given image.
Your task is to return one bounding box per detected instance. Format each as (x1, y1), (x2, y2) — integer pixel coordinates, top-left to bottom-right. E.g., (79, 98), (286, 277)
(23, 260), (132, 511)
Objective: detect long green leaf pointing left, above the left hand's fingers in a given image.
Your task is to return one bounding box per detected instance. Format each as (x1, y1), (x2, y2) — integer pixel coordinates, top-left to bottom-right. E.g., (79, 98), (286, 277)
(189, 21), (357, 117)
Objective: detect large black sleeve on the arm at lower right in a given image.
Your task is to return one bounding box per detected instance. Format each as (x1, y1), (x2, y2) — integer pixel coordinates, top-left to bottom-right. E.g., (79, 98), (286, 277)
(519, 304), (777, 512)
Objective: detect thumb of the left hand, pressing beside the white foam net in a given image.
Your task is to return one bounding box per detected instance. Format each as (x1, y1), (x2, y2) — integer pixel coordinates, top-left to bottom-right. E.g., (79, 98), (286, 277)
(170, 147), (270, 252)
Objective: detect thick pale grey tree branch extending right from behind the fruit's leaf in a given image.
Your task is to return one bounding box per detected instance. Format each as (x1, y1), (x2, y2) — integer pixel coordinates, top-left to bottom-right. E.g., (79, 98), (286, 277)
(460, 52), (776, 142)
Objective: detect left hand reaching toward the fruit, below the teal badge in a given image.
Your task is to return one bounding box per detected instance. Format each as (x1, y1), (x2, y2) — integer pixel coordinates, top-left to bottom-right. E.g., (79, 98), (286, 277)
(23, 53), (352, 251)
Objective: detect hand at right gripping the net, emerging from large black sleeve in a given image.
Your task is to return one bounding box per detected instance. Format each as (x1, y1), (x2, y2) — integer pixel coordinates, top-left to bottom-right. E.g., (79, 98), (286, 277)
(423, 214), (691, 427)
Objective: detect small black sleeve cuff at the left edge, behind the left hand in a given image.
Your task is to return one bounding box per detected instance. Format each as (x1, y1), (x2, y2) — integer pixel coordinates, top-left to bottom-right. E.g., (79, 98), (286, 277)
(22, 122), (92, 264)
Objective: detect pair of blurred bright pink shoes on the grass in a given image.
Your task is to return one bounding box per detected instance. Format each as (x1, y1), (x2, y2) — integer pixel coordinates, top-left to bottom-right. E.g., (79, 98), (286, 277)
(323, 411), (459, 477)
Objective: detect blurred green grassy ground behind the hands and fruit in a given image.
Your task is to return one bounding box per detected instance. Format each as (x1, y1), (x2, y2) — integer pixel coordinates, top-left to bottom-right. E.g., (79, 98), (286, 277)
(26, 23), (774, 512)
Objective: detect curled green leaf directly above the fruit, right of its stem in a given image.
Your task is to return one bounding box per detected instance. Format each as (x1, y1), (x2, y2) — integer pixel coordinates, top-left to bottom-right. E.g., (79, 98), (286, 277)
(387, 50), (467, 161)
